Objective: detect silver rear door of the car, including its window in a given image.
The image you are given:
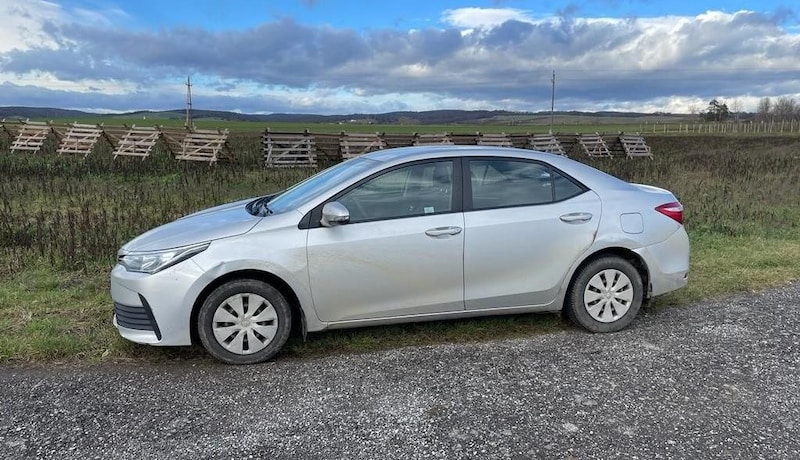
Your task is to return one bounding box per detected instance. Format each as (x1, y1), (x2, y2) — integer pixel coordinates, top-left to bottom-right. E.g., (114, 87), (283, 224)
(464, 158), (601, 310)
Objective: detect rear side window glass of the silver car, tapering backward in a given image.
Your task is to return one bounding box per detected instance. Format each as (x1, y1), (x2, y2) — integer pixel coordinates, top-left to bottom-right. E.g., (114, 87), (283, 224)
(468, 159), (586, 210)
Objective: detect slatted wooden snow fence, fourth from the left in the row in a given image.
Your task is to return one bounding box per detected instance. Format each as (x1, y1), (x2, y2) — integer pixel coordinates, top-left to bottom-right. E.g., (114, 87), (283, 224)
(161, 128), (233, 165)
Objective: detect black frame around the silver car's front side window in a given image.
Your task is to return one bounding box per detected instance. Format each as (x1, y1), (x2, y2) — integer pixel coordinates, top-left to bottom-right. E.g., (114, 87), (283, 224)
(298, 157), (464, 229)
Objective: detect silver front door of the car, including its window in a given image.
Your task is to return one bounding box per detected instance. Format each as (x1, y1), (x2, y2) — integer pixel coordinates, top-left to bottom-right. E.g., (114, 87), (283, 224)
(307, 160), (464, 322)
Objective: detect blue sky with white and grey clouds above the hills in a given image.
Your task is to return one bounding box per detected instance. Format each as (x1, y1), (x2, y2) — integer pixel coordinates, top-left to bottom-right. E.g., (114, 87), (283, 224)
(0, 0), (800, 114)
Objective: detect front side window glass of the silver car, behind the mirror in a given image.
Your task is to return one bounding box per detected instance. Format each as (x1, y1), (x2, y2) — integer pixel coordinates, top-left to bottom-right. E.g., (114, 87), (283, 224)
(337, 160), (453, 223)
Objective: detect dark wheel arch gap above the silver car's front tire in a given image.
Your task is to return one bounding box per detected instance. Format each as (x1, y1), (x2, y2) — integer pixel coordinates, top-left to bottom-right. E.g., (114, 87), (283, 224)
(189, 270), (306, 344)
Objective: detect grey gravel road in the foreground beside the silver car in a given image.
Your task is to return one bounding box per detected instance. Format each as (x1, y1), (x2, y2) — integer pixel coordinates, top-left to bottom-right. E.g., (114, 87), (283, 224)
(0, 284), (800, 459)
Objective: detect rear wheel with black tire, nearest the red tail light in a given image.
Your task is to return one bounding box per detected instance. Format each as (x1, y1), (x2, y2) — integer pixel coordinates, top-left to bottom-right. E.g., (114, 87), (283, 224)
(564, 256), (644, 332)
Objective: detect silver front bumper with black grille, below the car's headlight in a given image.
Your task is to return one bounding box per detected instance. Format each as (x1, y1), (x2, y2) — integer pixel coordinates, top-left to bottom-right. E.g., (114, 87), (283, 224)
(111, 259), (208, 346)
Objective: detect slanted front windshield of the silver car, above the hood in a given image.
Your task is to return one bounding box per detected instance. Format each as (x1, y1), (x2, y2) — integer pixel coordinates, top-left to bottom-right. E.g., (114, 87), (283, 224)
(268, 158), (376, 214)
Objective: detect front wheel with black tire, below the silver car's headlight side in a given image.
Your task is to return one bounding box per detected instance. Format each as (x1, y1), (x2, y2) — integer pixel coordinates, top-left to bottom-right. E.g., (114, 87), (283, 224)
(197, 279), (292, 364)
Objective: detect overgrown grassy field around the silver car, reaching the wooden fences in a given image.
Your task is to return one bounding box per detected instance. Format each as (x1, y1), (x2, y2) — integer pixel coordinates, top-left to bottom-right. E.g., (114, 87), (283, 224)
(0, 133), (800, 362)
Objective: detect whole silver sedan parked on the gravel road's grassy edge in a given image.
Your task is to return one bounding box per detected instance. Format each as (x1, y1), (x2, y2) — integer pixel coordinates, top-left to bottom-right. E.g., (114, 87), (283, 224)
(111, 146), (689, 364)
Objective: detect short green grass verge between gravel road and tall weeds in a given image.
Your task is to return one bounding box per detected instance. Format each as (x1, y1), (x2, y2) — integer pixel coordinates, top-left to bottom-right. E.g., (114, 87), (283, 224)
(0, 234), (800, 362)
